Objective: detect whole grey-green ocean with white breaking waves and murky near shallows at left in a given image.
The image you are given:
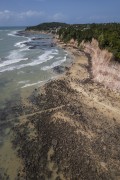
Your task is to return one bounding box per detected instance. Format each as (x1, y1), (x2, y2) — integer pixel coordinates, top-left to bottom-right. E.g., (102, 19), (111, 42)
(0, 27), (71, 179)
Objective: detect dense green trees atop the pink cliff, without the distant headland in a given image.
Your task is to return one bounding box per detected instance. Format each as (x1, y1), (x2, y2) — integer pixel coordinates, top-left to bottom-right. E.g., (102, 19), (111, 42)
(58, 23), (120, 62)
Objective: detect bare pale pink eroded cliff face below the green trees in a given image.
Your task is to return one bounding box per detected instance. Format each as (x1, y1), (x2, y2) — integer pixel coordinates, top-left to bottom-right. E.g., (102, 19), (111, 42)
(81, 39), (120, 90)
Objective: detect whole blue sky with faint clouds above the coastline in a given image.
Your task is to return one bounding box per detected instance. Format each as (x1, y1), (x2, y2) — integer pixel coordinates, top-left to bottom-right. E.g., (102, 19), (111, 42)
(0, 0), (120, 26)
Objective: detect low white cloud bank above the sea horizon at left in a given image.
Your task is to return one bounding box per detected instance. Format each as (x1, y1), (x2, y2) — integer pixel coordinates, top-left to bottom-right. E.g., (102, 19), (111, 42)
(0, 10), (67, 26)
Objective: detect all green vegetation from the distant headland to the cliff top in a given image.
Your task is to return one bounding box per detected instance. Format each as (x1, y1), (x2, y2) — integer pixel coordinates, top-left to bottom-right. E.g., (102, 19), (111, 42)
(26, 22), (120, 62)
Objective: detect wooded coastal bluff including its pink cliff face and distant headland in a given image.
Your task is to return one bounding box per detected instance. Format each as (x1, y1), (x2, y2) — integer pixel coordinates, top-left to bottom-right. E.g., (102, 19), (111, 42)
(26, 22), (120, 90)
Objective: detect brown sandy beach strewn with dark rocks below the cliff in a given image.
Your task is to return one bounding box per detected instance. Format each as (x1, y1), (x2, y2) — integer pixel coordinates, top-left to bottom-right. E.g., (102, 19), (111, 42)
(7, 37), (120, 180)
